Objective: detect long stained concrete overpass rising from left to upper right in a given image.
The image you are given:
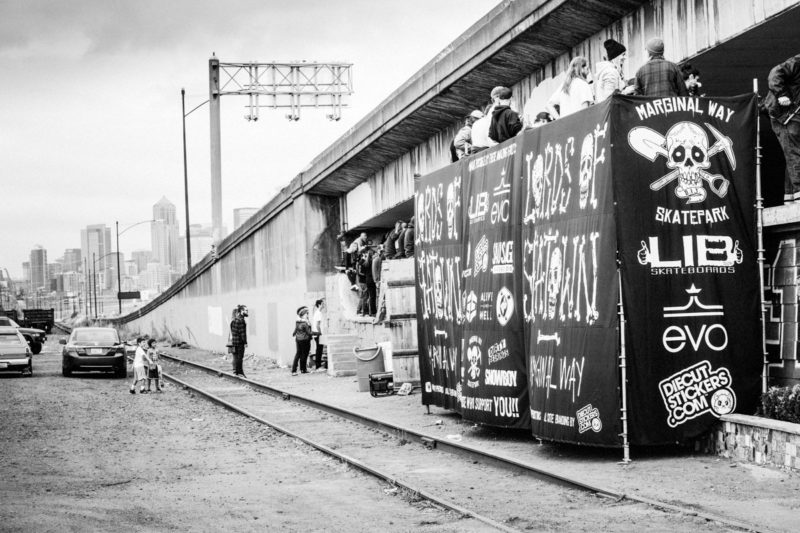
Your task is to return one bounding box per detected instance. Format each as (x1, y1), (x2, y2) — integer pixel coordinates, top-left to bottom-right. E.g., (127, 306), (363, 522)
(112, 0), (800, 374)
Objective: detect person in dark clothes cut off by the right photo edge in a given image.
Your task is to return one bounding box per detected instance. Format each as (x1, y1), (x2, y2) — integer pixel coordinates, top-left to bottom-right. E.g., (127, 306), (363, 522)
(764, 54), (800, 204)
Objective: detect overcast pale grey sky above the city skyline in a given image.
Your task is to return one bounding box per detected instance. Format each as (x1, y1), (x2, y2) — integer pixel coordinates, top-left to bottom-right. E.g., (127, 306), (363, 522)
(0, 0), (498, 277)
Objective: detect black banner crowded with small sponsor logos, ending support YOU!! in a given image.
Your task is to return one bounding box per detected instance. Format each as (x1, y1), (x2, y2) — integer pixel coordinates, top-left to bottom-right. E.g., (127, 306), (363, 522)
(461, 138), (530, 428)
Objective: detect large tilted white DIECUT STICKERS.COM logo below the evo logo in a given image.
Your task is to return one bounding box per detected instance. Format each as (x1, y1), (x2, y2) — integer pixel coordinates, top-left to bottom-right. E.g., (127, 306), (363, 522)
(658, 361), (736, 428)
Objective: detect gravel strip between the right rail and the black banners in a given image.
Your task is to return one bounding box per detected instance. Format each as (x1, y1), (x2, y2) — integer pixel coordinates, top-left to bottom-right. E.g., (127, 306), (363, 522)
(163, 340), (800, 531)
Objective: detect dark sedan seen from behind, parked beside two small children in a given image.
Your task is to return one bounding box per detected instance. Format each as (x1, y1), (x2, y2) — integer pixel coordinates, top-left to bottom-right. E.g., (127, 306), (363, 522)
(59, 328), (128, 379)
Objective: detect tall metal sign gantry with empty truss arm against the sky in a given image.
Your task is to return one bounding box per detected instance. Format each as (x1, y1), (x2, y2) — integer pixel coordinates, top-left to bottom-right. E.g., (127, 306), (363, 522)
(208, 56), (353, 243)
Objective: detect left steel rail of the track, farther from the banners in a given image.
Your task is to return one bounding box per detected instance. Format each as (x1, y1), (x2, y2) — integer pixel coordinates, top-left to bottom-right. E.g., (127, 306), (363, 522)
(162, 368), (522, 533)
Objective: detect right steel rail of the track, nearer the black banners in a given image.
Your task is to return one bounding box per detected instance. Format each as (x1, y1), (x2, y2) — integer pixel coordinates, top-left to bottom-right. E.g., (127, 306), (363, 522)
(159, 352), (776, 533)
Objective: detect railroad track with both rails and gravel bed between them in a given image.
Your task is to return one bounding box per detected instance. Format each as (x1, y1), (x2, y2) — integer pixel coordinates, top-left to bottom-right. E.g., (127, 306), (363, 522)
(156, 354), (769, 531)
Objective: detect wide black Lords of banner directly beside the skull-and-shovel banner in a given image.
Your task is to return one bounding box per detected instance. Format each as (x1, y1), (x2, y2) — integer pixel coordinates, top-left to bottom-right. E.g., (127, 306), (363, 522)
(518, 102), (621, 446)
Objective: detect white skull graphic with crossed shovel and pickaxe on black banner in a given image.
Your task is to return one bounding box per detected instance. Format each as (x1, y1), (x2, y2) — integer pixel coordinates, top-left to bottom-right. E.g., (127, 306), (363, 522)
(628, 121), (736, 204)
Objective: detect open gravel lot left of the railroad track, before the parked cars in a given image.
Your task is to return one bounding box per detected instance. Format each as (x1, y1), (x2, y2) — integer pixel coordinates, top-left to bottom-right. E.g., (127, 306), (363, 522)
(0, 345), (494, 532)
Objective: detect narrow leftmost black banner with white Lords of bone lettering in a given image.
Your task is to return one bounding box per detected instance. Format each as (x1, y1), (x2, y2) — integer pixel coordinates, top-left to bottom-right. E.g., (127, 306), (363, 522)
(415, 161), (464, 410)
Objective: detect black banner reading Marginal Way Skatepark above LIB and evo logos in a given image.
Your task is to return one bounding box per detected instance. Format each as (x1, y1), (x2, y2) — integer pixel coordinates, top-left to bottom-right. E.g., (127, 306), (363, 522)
(612, 95), (761, 444)
